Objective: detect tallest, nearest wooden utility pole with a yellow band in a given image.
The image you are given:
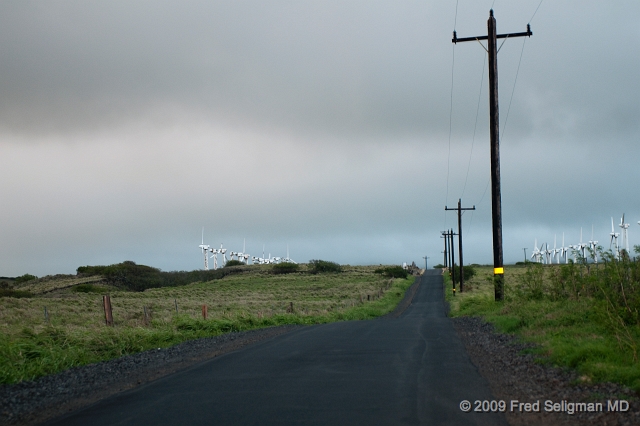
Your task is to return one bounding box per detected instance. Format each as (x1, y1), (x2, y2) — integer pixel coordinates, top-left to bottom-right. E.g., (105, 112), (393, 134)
(451, 9), (533, 300)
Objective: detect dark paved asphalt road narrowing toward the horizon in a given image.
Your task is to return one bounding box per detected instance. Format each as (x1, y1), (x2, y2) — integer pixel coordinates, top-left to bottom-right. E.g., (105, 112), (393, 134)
(47, 271), (506, 426)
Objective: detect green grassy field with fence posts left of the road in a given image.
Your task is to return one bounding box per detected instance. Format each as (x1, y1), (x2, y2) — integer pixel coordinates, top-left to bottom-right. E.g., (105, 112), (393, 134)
(0, 266), (414, 384)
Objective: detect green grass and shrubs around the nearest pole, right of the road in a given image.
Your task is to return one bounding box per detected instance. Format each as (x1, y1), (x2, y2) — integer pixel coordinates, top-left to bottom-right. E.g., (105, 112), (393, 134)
(445, 257), (640, 392)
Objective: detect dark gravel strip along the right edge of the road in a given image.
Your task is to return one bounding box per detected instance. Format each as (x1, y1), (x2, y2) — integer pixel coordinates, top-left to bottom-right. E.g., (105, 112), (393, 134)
(452, 317), (640, 425)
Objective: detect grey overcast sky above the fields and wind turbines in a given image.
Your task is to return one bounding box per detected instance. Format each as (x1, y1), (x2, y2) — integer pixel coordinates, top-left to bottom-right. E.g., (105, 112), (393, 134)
(0, 0), (640, 276)
